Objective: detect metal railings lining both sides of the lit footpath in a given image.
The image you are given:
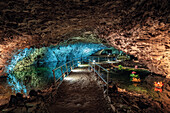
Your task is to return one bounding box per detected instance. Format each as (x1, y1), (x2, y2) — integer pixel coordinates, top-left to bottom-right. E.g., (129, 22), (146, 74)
(52, 56), (117, 95)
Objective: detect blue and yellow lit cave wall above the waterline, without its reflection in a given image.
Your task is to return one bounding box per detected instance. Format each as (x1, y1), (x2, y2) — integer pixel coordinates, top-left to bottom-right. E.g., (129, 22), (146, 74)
(7, 43), (106, 72)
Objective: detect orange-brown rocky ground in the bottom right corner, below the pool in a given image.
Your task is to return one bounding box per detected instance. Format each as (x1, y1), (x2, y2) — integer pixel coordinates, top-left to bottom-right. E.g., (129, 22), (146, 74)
(107, 89), (169, 113)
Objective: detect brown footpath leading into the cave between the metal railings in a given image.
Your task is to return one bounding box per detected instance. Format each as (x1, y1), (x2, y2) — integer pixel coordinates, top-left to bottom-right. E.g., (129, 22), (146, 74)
(48, 68), (110, 113)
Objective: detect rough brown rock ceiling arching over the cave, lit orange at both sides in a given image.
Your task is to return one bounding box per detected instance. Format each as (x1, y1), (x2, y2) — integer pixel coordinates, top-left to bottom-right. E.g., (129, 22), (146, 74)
(0, 0), (170, 77)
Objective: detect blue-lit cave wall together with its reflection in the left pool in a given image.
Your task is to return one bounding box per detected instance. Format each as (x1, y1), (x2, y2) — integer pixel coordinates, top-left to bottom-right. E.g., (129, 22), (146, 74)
(7, 43), (106, 93)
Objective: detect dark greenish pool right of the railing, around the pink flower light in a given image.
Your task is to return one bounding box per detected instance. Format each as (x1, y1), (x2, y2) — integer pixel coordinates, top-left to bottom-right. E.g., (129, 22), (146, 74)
(102, 69), (153, 93)
